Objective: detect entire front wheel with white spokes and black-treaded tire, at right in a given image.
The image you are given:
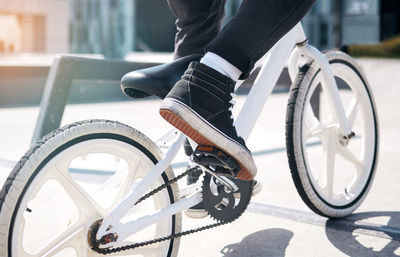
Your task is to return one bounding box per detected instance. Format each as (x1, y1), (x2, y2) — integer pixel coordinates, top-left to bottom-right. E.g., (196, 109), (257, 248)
(286, 51), (378, 217)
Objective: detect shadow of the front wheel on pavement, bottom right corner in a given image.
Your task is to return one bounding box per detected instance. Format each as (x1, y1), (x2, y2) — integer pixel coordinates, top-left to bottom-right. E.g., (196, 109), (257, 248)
(325, 212), (400, 257)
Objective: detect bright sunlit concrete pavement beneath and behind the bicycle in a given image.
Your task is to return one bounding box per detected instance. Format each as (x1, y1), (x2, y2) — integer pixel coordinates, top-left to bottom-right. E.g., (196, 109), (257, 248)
(0, 59), (400, 257)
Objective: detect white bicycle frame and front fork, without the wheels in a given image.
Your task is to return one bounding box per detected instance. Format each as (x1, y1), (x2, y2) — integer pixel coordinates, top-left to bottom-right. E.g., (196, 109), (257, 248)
(96, 23), (351, 247)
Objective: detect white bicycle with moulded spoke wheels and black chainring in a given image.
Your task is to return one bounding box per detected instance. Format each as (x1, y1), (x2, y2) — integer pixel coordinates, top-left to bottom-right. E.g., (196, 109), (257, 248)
(0, 23), (379, 257)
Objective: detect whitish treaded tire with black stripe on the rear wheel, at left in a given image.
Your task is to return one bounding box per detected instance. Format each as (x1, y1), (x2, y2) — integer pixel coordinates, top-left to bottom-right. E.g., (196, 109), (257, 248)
(0, 120), (181, 257)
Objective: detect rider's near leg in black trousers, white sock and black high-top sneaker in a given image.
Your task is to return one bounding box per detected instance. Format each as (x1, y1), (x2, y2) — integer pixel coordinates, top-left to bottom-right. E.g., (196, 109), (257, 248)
(160, 0), (315, 180)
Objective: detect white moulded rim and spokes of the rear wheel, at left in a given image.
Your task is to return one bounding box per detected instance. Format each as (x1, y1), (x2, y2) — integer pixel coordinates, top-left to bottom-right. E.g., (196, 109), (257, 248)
(12, 139), (172, 257)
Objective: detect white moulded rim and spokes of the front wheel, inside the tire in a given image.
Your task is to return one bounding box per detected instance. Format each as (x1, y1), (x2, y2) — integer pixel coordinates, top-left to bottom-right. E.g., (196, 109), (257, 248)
(302, 63), (376, 207)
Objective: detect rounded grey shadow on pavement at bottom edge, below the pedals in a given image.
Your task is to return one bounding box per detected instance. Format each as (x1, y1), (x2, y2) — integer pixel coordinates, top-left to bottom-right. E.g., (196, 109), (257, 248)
(221, 228), (293, 257)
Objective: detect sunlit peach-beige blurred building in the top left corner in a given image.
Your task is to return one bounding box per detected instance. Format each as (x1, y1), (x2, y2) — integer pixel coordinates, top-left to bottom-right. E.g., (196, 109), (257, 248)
(0, 0), (69, 53)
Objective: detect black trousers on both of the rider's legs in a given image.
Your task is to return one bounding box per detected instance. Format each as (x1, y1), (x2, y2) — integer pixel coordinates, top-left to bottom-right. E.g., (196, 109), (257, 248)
(168, 0), (316, 157)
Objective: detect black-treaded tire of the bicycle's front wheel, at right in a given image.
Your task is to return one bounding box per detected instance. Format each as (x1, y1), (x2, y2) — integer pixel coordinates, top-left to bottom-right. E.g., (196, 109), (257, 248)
(286, 51), (379, 218)
